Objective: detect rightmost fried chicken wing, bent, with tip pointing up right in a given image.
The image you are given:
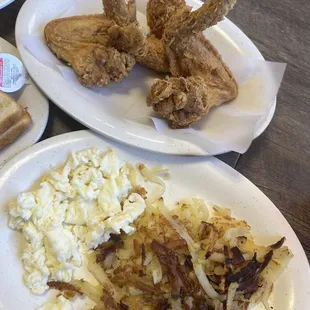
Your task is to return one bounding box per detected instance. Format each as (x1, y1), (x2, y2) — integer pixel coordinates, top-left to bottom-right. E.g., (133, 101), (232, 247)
(147, 0), (238, 128)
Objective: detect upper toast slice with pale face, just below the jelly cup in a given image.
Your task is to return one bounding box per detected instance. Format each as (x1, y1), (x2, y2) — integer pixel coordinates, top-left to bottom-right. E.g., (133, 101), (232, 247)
(0, 91), (24, 135)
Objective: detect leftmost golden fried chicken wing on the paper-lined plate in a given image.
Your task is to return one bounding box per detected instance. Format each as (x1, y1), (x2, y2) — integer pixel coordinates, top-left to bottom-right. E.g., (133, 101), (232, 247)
(44, 0), (142, 86)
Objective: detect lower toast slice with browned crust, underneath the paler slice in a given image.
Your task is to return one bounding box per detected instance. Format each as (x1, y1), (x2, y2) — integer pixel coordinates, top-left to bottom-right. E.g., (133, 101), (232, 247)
(0, 111), (32, 150)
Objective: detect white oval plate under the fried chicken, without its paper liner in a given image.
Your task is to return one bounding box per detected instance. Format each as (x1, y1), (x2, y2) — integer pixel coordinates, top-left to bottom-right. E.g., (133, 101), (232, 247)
(16, 0), (276, 155)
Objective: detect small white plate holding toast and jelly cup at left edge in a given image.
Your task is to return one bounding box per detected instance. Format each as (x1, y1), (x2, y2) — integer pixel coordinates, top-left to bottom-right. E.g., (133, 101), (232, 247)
(0, 38), (49, 167)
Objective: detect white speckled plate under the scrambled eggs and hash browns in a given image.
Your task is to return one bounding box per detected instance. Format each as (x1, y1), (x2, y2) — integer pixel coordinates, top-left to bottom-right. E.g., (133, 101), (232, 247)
(0, 131), (310, 310)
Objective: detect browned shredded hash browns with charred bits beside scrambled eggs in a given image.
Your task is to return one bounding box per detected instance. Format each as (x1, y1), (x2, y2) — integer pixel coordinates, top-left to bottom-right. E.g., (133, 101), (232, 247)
(45, 164), (292, 310)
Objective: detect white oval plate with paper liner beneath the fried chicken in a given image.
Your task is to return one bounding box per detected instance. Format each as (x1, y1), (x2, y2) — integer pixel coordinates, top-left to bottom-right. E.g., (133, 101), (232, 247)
(16, 0), (283, 155)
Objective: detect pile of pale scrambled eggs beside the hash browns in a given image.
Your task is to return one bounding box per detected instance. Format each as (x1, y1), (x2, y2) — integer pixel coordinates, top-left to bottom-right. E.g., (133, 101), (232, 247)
(9, 148), (146, 296)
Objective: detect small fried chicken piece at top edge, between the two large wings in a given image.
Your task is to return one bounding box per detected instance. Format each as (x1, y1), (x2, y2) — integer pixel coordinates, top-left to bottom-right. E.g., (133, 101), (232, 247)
(146, 0), (186, 39)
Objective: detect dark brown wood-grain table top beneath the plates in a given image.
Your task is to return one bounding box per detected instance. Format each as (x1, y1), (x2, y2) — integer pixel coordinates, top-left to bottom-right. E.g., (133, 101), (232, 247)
(0, 0), (310, 259)
